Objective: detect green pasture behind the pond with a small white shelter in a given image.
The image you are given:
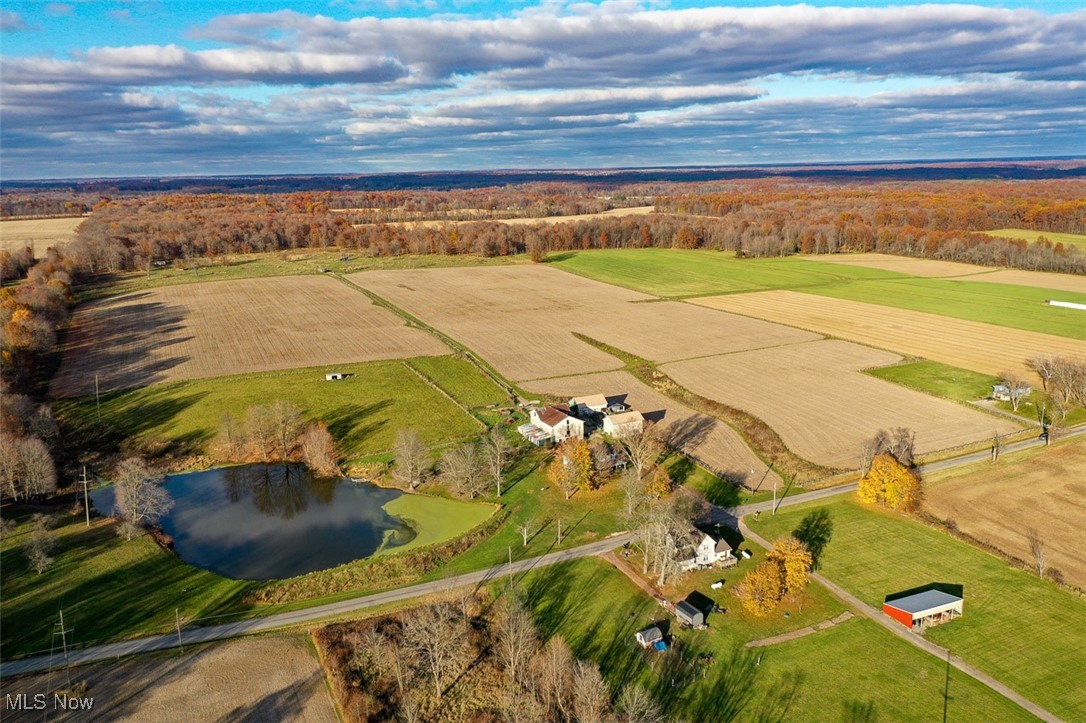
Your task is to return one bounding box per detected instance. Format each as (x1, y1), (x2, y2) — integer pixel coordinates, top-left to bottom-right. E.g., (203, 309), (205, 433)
(53, 356), (488, 459)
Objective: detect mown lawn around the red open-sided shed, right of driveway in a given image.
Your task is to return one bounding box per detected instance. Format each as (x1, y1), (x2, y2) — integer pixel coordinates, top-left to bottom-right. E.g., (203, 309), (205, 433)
(749, 492), (1086, 720)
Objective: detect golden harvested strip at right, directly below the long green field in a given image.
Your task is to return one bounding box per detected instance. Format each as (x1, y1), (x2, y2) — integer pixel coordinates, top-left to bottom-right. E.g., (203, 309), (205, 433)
(691, 291), (1086, 383)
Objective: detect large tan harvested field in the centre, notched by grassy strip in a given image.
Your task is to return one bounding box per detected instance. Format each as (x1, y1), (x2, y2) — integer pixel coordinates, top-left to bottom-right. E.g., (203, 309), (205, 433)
(349, 261), (818, 381)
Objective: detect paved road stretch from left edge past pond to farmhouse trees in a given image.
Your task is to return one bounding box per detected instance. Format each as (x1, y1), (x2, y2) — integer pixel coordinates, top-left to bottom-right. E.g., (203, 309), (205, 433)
(0, 533), (632, 677)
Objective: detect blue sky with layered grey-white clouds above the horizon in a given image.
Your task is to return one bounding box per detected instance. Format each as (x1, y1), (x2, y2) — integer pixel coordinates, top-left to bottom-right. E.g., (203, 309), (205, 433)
(0, 0), (1086, 180)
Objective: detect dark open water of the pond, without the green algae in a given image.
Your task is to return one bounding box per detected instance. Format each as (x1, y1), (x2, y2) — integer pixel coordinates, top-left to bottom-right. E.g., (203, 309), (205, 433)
(92, 465), (416, 580)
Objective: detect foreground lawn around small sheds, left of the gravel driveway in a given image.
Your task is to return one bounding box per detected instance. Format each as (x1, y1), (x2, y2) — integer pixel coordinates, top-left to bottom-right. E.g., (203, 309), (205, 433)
(514, 559), (1032, 721)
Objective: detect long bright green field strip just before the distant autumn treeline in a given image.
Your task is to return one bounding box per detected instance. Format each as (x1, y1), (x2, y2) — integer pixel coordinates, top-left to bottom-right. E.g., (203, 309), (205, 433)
(551, 249), (1086, 340)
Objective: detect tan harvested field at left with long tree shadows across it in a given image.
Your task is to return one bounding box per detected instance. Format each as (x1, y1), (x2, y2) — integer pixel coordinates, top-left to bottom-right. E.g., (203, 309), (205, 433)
(52, 276), (449, 397)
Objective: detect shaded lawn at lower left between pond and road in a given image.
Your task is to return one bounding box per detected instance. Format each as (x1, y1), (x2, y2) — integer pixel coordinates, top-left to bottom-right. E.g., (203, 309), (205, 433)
(0, 515), (250, 659)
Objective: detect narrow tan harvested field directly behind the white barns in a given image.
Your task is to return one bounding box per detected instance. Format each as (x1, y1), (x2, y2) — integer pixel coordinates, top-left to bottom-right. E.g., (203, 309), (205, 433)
(527, 371), (780, 486)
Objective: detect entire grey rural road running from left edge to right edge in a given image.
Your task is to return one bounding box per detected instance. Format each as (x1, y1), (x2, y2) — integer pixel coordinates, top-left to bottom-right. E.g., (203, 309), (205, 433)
(0, 419), (1086, 677)
